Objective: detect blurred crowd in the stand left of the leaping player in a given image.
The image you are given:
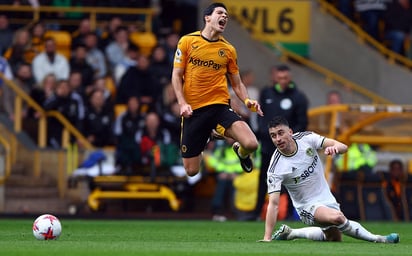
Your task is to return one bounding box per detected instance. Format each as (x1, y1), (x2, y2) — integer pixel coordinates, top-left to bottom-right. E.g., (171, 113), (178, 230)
(0, 0), (197, 175)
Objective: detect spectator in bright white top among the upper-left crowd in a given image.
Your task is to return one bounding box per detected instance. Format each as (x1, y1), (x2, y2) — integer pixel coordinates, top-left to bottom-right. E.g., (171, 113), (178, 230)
(32, 38), (70, 83)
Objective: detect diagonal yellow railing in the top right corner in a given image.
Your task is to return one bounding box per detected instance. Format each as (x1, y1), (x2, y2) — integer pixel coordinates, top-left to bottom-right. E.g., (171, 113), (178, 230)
(317, 0), (412, 68)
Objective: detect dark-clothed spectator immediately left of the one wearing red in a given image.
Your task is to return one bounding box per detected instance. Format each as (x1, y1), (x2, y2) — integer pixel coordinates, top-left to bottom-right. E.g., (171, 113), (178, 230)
(114, 96), (144, 175)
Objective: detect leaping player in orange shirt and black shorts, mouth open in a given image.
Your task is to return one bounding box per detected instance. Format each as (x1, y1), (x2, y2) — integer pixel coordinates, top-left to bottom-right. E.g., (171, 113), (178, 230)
(172, 3), (263, 176)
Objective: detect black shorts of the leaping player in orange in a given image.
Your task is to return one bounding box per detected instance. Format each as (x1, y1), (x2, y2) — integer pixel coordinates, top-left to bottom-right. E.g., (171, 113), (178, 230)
(180, 104), (241, 158)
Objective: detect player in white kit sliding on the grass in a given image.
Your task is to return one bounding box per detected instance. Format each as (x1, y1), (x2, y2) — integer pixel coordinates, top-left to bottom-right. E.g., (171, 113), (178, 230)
(260, 117), (399, 243)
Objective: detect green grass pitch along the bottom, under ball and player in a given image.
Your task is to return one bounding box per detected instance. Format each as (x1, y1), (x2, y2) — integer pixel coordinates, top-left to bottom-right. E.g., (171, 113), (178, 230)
(0, 219), (412, 256)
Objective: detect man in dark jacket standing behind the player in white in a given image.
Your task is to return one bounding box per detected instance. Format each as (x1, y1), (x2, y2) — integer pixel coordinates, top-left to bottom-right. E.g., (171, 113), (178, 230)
(256, 65), (309, 220)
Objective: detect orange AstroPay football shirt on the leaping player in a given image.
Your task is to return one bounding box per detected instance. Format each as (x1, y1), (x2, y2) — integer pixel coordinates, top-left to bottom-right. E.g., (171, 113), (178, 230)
(174, 31), (239, 110)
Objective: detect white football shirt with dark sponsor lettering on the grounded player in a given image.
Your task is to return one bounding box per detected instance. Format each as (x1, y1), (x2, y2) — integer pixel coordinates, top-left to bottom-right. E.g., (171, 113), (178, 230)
(267, 132), (336, 210)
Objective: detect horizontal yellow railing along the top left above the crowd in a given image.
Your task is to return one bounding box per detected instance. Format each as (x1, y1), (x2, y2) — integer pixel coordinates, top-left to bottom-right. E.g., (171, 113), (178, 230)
(0, 5), (155, 32)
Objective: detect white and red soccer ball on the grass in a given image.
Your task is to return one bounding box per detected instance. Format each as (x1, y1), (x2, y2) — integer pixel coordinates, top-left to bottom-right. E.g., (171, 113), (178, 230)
(33, 214), (62, 240)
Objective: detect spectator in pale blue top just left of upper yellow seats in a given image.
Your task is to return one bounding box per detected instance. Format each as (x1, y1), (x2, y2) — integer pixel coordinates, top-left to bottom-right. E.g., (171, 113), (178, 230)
(105, 26), (130, 72)
